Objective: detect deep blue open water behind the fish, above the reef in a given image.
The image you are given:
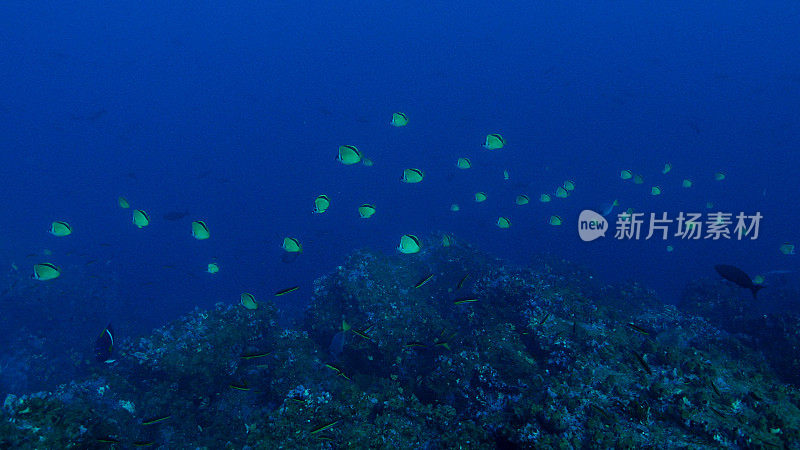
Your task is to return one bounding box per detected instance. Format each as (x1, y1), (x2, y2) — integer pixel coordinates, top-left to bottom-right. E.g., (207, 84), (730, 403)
(0, 1), (800, 388)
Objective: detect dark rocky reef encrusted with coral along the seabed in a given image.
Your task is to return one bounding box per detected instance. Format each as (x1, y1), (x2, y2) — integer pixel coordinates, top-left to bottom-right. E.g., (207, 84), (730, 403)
(0, 236), (800, 449)
